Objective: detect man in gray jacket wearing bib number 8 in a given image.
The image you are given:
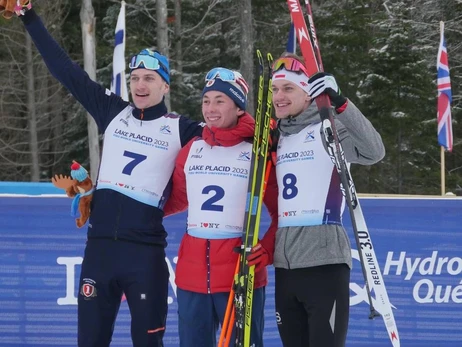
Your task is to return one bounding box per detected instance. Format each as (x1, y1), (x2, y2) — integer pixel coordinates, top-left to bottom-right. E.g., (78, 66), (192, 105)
(272, 53), (385, 347)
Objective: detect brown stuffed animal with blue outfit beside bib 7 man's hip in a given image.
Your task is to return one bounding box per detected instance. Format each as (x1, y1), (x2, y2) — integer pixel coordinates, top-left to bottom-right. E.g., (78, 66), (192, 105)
(51, 160), (94, 228)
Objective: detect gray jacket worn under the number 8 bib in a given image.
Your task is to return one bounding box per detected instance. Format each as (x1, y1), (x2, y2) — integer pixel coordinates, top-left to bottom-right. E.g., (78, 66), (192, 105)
(274, 100), (385, 269)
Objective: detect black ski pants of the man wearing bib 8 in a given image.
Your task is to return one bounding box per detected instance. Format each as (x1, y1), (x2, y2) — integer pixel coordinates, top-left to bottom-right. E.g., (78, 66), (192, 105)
(275, 264), (350, 347)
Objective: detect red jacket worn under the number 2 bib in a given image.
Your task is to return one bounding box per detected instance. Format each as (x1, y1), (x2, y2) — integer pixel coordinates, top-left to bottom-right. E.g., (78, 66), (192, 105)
(164, 113), (278, 293)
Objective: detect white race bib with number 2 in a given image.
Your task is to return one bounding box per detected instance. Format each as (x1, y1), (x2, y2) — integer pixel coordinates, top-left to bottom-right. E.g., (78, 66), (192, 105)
(184, 139), (252, 239)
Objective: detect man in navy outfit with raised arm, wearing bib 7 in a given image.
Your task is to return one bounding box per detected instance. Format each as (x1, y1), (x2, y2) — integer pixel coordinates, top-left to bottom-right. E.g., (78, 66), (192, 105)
(18, 3), (202, 347)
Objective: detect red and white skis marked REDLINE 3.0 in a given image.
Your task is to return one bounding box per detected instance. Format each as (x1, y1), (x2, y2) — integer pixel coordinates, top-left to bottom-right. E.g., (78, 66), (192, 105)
(287, 0), (400, 347)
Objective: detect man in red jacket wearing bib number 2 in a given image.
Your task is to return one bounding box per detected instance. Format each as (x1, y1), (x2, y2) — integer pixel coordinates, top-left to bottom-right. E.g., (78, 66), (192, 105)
(164, 68), (278, 347)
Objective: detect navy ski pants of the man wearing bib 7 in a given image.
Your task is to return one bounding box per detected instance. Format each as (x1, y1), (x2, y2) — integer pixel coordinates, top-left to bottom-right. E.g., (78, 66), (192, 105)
(78, 239), (169, 347)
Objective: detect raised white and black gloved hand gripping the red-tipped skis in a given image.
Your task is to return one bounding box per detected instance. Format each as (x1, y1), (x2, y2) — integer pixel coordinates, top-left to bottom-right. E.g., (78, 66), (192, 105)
(308, 72), (347, 109)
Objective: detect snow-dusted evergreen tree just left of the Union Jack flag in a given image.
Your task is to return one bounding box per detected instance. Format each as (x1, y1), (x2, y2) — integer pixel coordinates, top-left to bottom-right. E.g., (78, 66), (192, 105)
(359, 2), (437, 194)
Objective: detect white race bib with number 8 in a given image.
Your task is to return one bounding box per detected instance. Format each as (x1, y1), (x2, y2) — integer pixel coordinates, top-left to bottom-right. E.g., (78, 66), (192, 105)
(276, 123), (344, 227)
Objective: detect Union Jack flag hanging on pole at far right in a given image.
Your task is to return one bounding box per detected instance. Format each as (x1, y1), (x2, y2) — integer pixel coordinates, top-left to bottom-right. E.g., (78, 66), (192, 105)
(436, 22), (452, 152)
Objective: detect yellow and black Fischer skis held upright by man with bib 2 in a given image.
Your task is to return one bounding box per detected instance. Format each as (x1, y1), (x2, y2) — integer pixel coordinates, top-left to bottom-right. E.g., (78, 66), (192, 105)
(218, 50), (273, 347)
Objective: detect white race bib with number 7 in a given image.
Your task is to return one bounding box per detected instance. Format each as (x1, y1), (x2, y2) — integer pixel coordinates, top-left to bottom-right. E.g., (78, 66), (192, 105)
(96, 106), (181, 207)
